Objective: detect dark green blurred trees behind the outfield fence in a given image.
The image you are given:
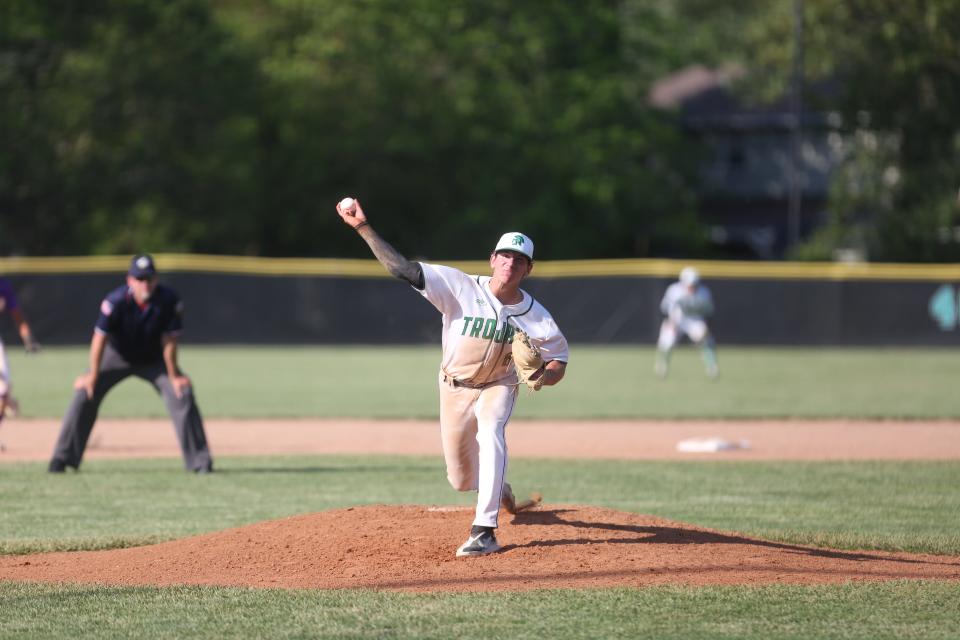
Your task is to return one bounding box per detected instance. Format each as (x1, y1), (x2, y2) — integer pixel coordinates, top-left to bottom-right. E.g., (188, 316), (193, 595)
(0, 0), (960, 260)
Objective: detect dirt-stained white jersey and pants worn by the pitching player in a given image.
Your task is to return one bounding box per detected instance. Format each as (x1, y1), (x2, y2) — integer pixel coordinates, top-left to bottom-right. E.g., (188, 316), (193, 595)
(420, 263), (569, 527)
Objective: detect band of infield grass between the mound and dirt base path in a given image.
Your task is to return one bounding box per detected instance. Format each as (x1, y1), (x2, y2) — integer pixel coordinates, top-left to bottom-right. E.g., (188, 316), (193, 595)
(0, 454), (960, 555)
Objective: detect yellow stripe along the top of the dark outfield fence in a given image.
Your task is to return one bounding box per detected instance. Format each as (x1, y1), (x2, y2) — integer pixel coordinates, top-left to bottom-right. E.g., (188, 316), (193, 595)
(0, 253), (960, 282)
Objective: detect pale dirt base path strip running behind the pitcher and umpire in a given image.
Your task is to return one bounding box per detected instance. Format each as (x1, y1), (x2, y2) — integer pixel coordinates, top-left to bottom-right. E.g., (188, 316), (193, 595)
(0, 419), (960, 464)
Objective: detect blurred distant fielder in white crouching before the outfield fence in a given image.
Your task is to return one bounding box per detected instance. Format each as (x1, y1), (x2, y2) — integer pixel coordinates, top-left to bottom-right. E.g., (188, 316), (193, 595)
(654, 267), (720, 378)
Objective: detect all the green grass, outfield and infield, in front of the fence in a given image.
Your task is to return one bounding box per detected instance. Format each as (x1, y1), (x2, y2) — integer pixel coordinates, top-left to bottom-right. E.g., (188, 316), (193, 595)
(0, 346), (960, 639)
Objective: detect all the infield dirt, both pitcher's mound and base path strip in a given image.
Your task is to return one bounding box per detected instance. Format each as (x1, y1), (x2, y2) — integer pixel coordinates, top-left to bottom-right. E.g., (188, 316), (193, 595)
(0, 421), (960, 591)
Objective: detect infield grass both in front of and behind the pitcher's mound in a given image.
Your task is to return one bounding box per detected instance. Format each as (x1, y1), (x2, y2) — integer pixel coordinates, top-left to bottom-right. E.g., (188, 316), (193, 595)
(0, 456), (960, 638)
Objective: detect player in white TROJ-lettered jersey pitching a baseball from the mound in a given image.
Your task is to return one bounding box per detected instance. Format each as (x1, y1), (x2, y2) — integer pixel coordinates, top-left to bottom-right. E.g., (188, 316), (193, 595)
(337, 199), (568, 556)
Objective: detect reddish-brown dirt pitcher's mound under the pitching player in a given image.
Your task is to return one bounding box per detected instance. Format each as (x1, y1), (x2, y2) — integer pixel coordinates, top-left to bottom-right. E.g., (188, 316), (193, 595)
(0, 506), (960, 591)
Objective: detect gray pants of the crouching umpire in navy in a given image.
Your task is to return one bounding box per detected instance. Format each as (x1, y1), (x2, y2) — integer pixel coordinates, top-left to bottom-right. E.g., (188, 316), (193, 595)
(53, 344), (213, 471)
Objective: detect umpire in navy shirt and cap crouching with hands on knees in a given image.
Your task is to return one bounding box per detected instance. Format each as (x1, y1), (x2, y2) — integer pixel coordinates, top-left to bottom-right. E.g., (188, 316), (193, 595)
(49, 255), (213, 473)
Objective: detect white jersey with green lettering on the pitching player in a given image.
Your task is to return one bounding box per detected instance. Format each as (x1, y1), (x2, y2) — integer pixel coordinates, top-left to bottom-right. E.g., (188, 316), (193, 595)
(418, 262), (569, 385)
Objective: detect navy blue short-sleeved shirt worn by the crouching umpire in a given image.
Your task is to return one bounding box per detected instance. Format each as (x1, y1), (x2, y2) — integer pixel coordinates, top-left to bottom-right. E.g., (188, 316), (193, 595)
(96, 284), (183, 364)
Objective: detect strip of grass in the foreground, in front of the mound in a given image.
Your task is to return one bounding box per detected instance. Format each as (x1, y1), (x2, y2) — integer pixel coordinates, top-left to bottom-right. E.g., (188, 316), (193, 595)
(0, 582), (960, 640)
